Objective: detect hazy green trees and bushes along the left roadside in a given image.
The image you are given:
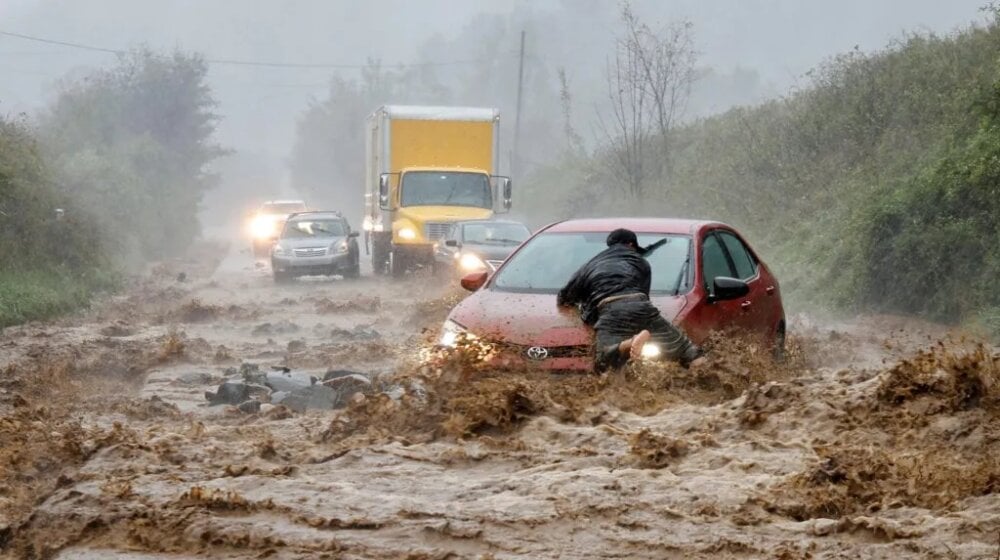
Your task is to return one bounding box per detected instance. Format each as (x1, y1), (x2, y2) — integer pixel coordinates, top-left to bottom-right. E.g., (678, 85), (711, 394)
(0, 50), (223, 328)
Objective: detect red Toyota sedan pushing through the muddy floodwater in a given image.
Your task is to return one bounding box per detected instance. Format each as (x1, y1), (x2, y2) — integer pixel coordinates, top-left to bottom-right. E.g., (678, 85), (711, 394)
(440, 218), (785, 370)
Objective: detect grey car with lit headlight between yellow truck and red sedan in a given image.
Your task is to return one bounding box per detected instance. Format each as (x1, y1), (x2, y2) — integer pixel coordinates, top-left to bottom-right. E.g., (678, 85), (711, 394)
(434, 220), (531, 276)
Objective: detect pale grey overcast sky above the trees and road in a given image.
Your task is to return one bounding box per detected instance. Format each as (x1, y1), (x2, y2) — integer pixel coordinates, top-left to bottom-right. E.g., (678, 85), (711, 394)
(0, 0), (986, 183)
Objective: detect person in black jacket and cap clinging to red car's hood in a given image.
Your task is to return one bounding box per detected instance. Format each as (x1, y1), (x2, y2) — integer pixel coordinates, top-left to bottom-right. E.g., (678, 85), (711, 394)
(556, 229), (705, 372)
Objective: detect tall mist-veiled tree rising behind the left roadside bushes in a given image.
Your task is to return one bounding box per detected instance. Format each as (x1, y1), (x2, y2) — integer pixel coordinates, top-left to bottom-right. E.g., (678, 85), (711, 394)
(41, 49), (225, 259)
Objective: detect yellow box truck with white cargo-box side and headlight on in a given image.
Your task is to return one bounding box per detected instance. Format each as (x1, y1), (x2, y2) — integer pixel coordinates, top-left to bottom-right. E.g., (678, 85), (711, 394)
(362, 105), (511, 277)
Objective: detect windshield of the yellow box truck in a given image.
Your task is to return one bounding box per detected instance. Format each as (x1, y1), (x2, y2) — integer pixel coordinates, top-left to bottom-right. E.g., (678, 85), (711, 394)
(400, 171), (493, 208)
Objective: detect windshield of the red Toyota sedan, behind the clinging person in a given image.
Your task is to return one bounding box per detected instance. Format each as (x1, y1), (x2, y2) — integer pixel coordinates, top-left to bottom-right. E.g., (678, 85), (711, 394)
(493, 232), (691, 294)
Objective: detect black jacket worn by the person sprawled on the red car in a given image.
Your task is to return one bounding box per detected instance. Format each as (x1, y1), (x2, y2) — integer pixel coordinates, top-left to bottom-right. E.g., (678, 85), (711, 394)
(556, 244), (652, 325)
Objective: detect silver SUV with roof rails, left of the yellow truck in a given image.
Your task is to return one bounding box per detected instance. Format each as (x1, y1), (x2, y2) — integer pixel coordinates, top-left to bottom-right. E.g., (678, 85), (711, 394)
(271, 212), (361, 282)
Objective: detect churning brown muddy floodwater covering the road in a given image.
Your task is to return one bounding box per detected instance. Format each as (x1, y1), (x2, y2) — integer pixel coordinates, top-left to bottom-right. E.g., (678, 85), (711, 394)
(0, 242), (1000, 559)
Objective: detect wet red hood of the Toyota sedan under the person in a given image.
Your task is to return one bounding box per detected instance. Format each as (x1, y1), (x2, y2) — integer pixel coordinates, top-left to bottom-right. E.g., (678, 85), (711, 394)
(448, 290), (686, 347)
